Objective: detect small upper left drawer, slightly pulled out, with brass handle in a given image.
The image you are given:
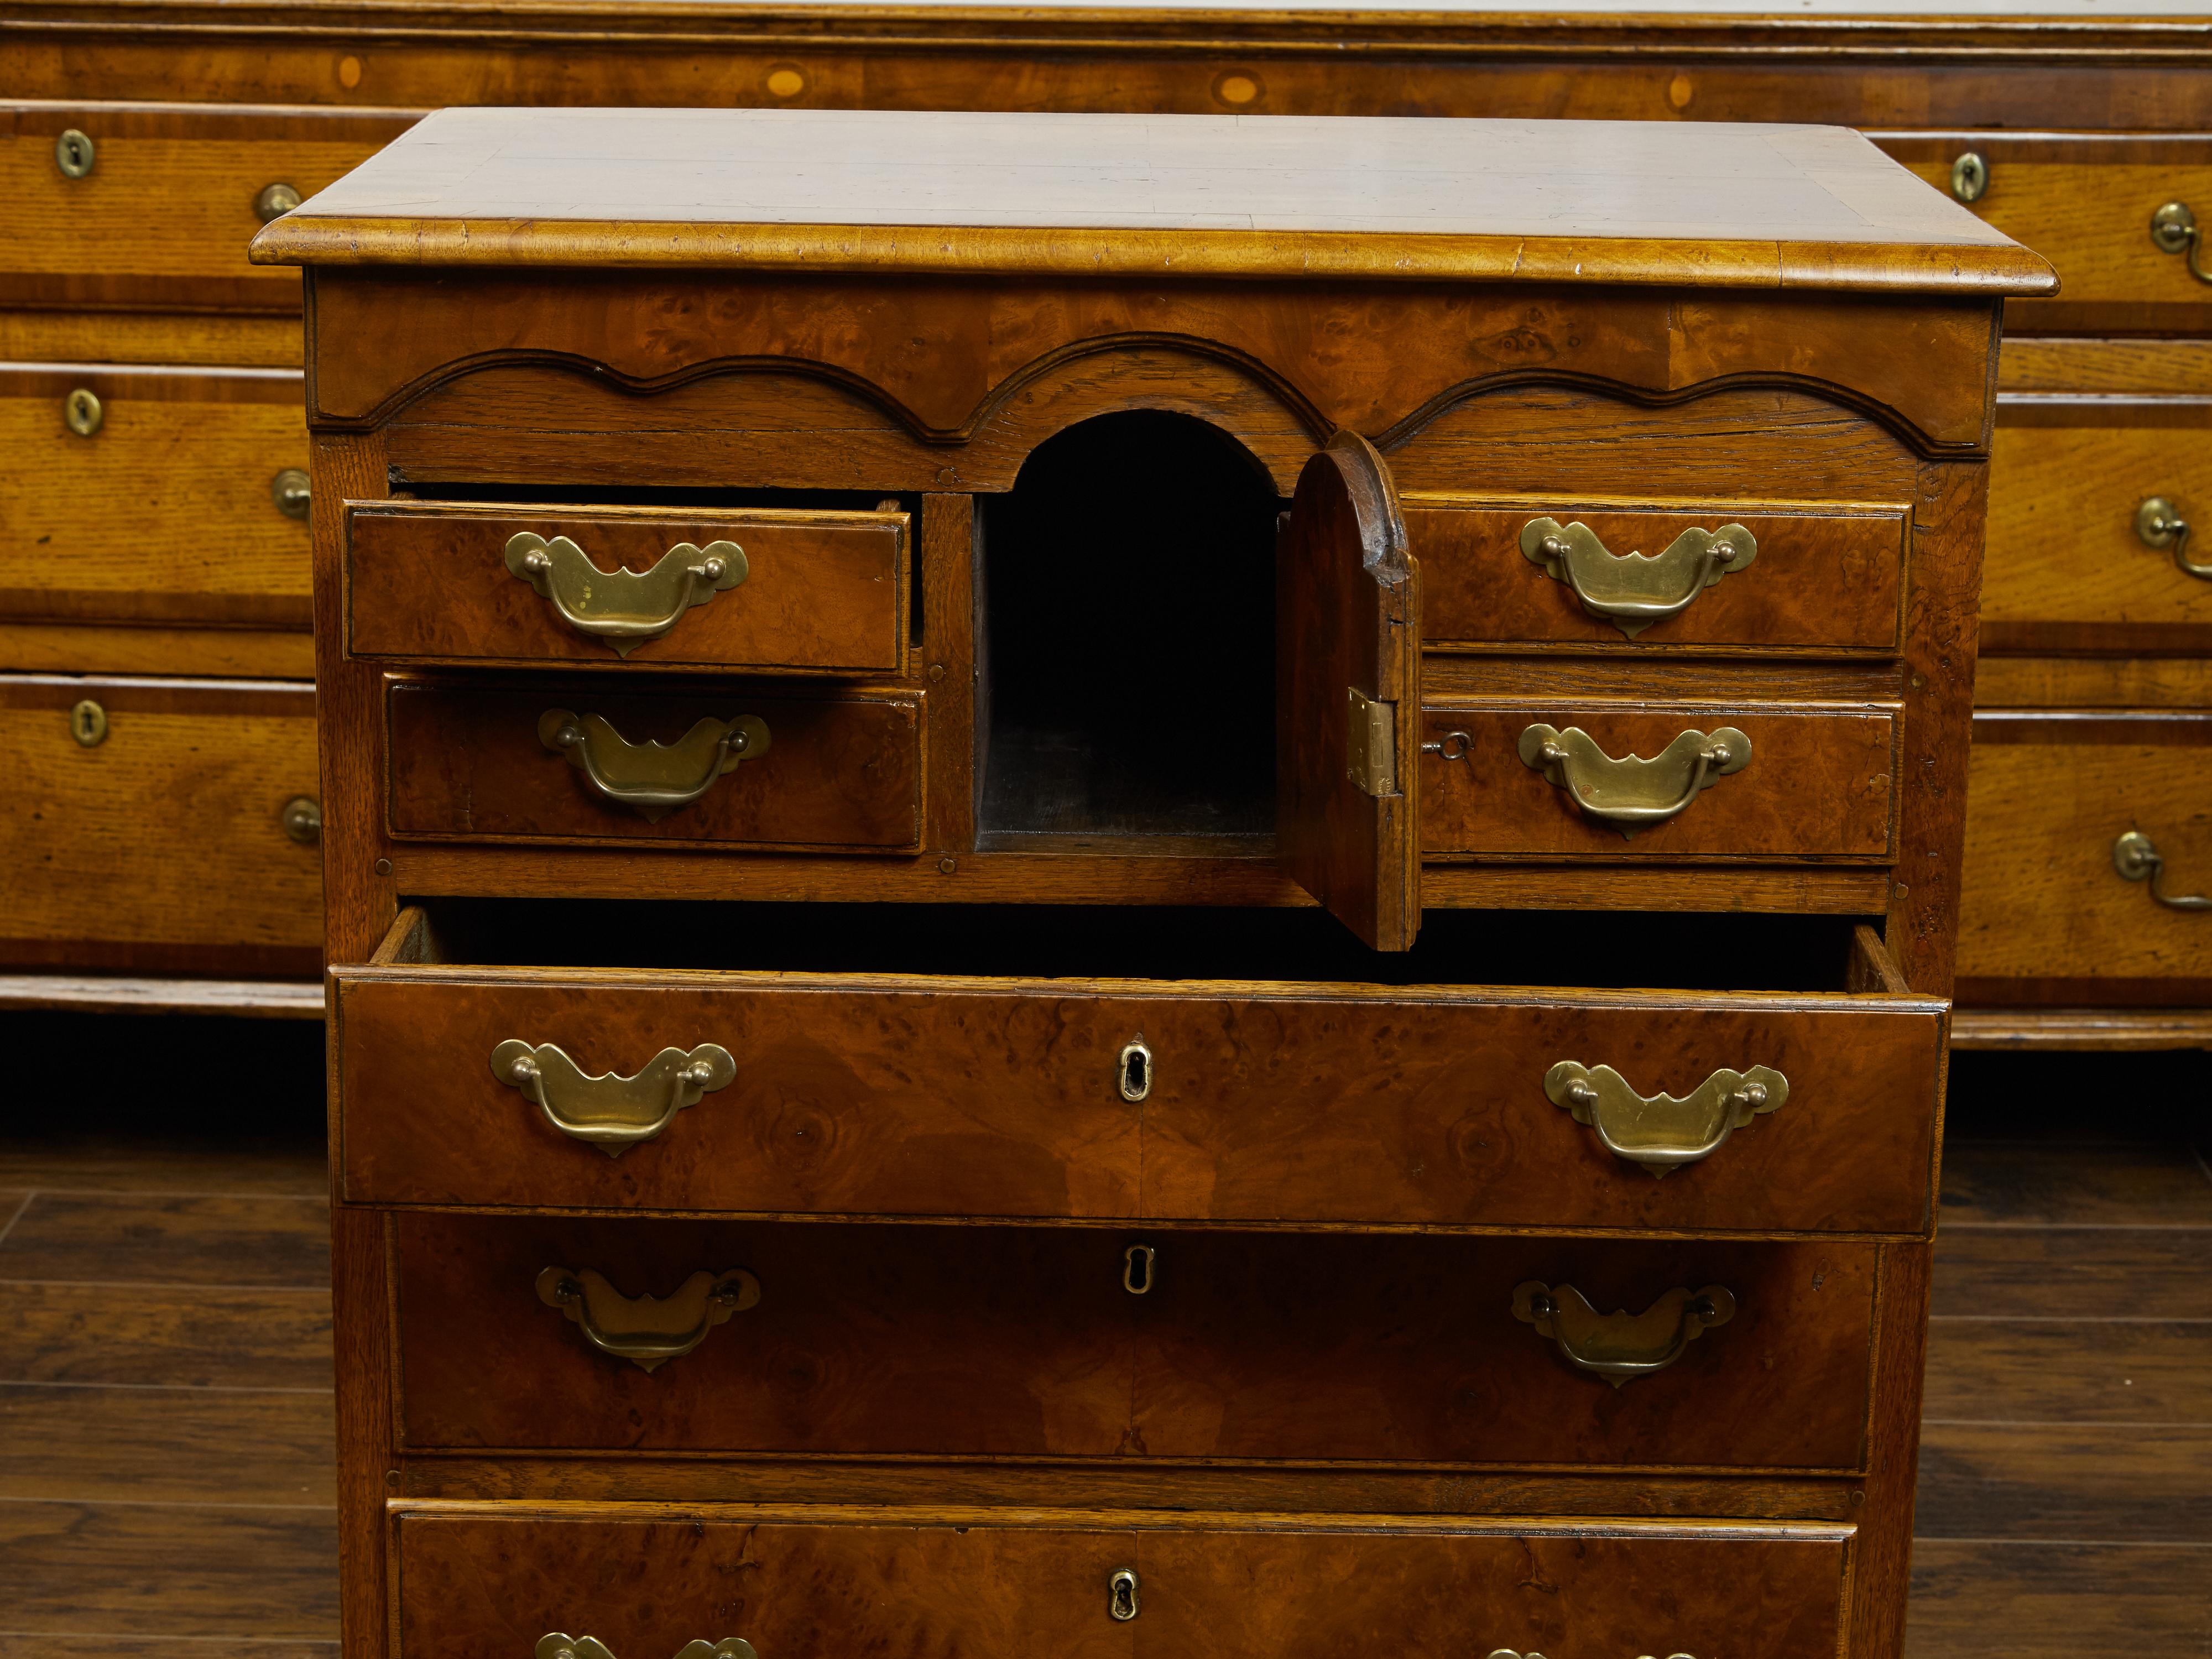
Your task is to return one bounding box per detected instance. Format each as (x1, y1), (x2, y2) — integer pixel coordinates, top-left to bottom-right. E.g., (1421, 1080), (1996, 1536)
(345, 502), (907, 675)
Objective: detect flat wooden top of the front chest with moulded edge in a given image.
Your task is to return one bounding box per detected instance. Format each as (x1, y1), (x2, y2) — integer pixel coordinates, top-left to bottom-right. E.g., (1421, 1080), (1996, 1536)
(252, 108), (2055, 294)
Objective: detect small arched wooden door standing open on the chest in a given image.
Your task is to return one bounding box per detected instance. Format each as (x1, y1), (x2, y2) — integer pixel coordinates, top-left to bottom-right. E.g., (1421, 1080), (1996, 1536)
(1274, 431), (1420, 951)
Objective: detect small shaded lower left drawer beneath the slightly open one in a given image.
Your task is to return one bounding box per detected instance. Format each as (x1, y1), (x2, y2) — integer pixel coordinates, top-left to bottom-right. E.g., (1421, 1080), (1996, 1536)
(387, 679), (922, 852)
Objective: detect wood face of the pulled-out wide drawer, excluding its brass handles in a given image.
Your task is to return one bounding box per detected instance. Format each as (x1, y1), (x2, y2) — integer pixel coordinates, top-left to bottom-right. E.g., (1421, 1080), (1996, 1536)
(334, 918), (1942, 1234)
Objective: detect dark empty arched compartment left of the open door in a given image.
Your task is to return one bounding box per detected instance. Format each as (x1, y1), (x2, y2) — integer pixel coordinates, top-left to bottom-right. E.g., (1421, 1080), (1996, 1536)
(978, 411), (1285, 847)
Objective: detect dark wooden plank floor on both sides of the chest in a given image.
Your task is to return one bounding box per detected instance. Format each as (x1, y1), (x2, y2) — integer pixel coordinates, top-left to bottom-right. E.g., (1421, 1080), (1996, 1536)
(0, 1018), (2212, 1659)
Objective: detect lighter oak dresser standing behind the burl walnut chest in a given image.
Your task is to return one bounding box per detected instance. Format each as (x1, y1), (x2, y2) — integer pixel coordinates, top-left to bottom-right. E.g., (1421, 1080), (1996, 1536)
(0, 0), (2212, 1046)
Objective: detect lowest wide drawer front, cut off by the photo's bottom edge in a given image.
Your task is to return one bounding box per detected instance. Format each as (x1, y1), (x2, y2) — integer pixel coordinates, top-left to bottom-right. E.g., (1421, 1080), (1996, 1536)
(392, 1506), (1851, 1659)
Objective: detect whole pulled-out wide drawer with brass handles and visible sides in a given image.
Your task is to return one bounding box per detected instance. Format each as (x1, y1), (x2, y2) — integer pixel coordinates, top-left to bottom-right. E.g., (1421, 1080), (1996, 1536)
(334, 905), (1947, 1237)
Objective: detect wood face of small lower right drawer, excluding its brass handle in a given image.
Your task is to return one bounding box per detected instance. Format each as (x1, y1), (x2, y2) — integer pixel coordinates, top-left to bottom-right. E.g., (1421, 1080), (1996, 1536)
(1420, 703), (1898, 863)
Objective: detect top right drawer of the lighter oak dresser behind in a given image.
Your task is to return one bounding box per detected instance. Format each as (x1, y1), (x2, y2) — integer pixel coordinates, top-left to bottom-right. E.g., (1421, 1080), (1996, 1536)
(1869, 133), (2212, 332)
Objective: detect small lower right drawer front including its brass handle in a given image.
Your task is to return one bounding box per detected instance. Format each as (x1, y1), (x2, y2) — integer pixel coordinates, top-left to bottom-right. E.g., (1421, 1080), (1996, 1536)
(1420, 701), (1898, 863)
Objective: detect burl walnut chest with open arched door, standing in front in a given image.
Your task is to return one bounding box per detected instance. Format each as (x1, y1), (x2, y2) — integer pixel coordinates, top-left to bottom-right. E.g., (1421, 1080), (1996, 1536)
(254, 111), (2053, 1659)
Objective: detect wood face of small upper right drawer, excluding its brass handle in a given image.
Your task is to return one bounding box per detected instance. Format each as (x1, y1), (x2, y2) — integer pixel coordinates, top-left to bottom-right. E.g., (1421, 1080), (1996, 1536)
(1405, 495), (1911, 655)
